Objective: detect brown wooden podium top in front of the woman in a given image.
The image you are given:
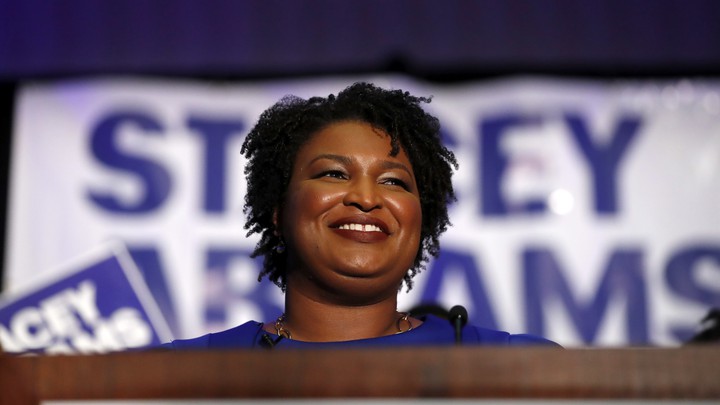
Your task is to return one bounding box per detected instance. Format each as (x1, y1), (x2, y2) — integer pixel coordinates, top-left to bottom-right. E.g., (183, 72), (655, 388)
(0, 346), (720, 405)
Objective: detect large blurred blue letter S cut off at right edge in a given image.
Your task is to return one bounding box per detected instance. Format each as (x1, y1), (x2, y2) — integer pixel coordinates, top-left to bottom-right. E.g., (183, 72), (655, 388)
(665, 245), (720, 341)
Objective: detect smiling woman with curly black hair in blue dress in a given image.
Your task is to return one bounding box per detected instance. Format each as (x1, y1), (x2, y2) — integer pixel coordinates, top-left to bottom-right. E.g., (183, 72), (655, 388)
(168, 83), (552, 348)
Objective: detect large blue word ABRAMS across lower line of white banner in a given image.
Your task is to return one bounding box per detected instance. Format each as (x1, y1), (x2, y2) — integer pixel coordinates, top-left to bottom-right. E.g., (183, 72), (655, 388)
(191, 245), (720, 345)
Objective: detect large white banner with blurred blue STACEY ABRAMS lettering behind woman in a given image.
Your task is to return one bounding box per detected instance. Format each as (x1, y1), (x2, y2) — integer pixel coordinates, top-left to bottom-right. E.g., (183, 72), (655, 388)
(6, 76), (720, 346)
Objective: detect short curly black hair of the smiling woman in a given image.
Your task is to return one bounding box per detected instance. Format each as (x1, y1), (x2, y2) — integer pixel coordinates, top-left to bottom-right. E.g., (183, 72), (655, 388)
(241, 83), (458, 291)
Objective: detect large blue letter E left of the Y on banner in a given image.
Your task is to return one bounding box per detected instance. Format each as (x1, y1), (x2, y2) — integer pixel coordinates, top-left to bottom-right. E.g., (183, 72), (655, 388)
(478, 114), (545, 216)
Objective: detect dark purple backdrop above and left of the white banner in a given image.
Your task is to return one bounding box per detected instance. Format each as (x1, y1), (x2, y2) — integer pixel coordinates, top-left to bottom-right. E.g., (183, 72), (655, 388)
(0, 0), (720, 289)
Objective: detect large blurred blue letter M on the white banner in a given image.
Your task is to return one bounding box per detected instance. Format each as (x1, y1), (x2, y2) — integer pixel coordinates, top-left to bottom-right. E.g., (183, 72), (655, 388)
(523, 248), (648, 344)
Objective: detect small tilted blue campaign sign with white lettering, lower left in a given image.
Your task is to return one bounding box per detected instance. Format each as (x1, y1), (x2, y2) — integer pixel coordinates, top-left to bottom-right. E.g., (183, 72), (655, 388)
(0, 243), (171, 354)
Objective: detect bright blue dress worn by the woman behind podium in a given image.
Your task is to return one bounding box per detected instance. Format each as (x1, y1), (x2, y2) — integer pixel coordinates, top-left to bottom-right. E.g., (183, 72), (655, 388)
(163, 315), (559, 349)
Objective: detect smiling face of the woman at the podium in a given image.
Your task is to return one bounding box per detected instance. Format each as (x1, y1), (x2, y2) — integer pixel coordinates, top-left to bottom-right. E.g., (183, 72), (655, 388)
(279, 121), (422, 302)
